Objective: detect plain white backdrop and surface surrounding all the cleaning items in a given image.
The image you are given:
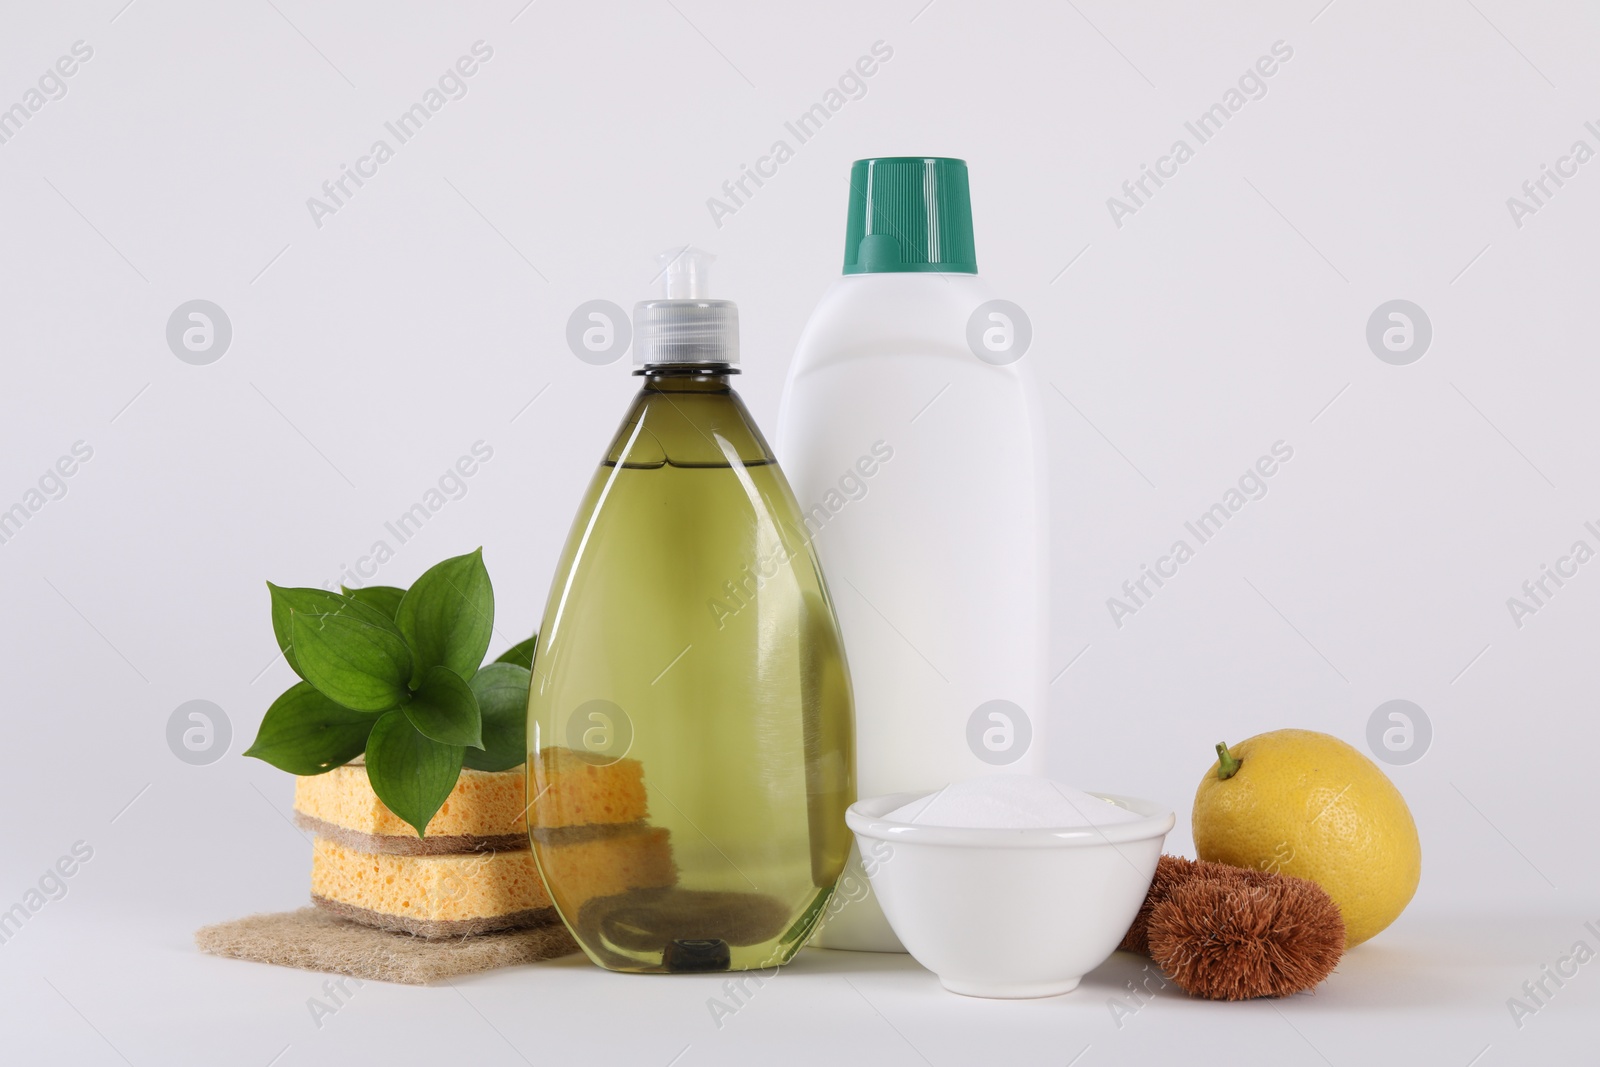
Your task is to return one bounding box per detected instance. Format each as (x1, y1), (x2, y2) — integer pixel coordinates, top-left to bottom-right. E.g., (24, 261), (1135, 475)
(0, 0), (1600, 1067)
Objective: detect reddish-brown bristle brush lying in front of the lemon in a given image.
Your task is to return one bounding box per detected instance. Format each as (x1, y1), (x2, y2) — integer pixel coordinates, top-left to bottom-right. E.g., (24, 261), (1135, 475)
(1122, 856), (1344, 1000)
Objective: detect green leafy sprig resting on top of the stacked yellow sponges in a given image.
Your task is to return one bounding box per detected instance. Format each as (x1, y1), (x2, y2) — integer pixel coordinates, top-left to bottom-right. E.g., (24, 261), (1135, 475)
(245, 549), (538, 837)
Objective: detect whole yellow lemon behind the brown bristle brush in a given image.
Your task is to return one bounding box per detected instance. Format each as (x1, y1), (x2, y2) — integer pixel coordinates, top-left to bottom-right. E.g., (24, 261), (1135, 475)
(1194, 729), (1422, 947)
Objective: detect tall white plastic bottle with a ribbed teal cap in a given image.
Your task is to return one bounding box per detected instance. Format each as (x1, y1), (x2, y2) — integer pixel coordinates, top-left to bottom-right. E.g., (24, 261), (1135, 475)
(778, 157), (1050, 952)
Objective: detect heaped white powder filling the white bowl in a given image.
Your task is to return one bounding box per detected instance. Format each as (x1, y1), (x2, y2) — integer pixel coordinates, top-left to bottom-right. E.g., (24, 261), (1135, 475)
(886, 774), (1144, 830)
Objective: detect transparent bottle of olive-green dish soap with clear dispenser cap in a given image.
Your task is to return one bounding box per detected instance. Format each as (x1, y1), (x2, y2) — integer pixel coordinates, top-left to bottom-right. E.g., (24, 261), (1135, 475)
(528, 250), (854, 971)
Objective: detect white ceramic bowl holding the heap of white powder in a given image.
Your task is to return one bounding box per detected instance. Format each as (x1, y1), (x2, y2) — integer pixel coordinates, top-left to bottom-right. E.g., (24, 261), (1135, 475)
(845, 793), (1176, 998)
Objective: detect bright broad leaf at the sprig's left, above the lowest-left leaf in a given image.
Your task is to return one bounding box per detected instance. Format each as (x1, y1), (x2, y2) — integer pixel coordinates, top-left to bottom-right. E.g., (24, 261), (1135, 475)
(290, 611), (411, 712)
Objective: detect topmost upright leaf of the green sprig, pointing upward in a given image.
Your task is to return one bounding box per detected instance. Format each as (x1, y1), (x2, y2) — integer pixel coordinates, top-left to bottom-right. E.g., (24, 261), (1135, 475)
(395, 549), (494, 678)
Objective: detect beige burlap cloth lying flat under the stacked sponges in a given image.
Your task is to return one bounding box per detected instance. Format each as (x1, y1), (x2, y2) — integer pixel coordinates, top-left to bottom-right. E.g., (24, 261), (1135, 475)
(195, 907), (578, 985)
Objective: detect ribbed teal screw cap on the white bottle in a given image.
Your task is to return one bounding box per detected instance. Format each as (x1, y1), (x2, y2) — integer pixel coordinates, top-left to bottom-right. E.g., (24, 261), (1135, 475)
(845, 155), (978, 274)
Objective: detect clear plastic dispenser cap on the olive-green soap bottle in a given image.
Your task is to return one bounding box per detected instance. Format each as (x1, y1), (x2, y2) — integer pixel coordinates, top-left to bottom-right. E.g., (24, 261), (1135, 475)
(634, 245), (739, 366)
